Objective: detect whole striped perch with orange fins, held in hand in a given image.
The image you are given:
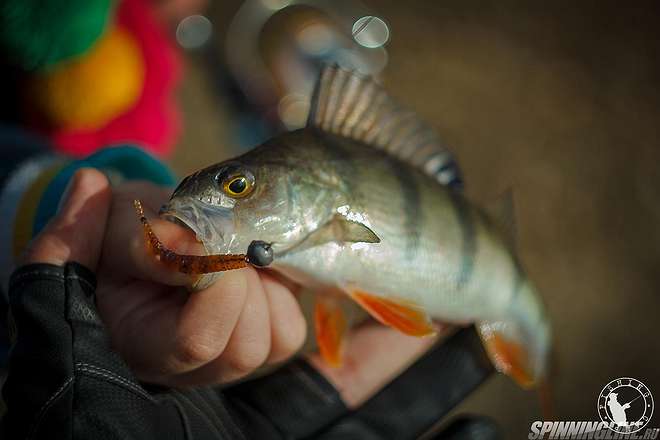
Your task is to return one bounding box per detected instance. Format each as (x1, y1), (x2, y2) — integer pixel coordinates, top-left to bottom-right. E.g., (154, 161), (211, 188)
(150, 67), (550, 387)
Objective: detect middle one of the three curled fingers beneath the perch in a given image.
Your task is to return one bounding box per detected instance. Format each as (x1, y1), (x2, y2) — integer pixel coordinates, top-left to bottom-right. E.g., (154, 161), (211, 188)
(166, 268), (271, 386)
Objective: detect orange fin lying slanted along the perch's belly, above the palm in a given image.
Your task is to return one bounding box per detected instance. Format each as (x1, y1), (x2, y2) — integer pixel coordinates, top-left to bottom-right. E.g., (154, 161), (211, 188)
(350, 290), (436, 336)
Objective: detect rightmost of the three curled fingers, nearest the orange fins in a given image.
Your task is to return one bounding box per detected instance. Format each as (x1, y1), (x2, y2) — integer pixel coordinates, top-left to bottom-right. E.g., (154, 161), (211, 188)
(259, 272), (307, 364)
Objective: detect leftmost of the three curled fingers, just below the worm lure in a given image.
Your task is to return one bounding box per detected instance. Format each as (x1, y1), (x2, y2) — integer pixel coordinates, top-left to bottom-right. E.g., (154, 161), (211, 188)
(115, 269), (247, 384)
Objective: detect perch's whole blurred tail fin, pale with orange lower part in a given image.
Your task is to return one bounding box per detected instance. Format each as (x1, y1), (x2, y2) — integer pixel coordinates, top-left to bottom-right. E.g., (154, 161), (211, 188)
(477, 282), (550, 388)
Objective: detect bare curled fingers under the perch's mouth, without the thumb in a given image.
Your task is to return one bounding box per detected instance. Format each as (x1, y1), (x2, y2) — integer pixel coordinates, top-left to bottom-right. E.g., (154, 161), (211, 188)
(87, 177), (306, 386)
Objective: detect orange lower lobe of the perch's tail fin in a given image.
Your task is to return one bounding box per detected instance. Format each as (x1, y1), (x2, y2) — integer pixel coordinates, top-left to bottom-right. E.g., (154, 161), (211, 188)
(482, 331), (536, 388)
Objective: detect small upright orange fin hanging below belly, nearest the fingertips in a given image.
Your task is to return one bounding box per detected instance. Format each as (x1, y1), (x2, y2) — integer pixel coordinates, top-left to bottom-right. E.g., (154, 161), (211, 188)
(314, 295), (346, 368)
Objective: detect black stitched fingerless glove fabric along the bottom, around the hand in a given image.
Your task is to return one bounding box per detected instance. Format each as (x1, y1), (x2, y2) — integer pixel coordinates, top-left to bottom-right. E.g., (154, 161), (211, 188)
(3, 263), (499, 440)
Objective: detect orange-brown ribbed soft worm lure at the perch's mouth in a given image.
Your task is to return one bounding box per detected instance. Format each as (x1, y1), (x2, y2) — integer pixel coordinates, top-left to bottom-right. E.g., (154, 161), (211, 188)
(133, 200), (248, 275)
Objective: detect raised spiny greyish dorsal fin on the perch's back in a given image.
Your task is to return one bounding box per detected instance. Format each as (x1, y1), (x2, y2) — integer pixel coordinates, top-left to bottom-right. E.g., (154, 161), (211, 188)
(307, 65), (462, 187)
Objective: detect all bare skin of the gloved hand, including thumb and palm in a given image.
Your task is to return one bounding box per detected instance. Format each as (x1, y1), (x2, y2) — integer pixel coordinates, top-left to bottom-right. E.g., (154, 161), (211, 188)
(23, 170), (440, 406)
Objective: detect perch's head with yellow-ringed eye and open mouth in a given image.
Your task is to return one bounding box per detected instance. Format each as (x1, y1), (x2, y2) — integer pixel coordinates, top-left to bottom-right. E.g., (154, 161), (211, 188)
(160, 141), (337, 260)
